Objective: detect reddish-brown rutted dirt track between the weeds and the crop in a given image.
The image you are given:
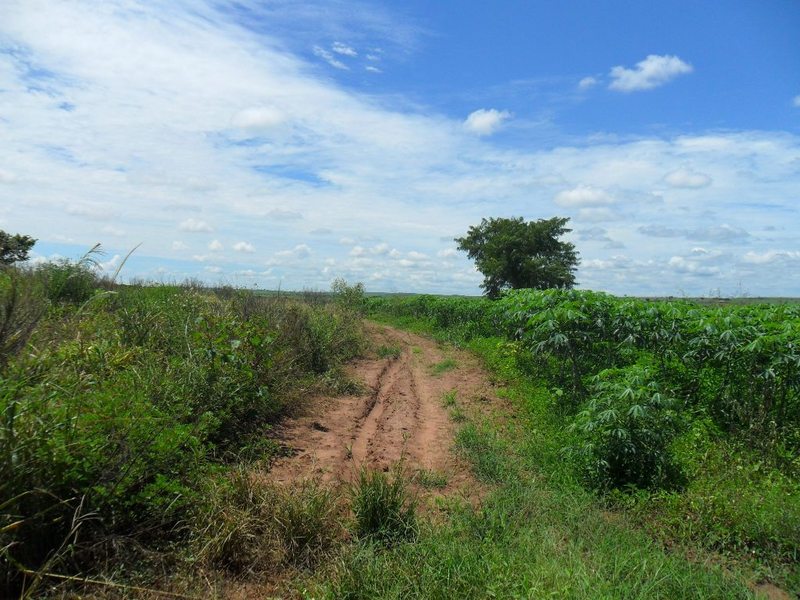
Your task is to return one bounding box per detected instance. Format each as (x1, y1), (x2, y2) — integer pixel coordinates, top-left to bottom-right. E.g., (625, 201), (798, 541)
(270, 325), (491, 493)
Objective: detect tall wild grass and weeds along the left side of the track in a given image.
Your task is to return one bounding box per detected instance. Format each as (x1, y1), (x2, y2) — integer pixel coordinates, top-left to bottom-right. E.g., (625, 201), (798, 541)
(0, 278), (363, 589)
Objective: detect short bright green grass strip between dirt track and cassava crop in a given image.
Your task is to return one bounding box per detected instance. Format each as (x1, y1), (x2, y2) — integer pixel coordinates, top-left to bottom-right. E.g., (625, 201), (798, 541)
(309, 316), (753, 599)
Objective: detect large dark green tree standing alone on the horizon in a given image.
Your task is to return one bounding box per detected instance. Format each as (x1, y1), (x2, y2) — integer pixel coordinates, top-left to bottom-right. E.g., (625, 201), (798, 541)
(455, 217), (579, 298)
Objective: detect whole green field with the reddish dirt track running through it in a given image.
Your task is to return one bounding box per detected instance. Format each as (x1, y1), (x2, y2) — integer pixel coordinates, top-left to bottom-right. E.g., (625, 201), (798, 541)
(0, 263), (800, 598)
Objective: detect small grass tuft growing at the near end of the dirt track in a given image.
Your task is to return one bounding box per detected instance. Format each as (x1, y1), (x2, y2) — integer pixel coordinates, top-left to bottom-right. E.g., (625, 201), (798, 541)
(352, 467), (418, 546)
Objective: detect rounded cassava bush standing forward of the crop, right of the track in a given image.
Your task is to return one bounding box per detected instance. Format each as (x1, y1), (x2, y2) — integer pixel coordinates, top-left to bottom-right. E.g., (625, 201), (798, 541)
(570, 365), (680, 489)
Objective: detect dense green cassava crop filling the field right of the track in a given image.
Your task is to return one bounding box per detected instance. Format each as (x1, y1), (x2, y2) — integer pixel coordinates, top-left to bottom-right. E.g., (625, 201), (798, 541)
(367, 290), (800, 596)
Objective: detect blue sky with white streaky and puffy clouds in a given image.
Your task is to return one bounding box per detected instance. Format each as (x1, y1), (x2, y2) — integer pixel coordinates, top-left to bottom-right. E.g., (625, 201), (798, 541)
(0, 0), (800, 296)
